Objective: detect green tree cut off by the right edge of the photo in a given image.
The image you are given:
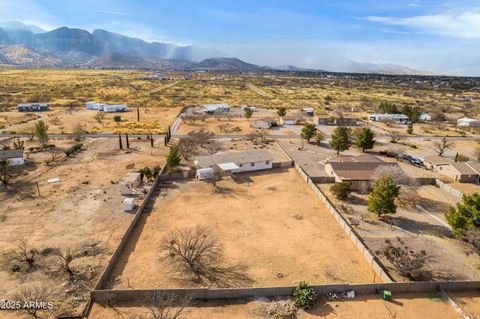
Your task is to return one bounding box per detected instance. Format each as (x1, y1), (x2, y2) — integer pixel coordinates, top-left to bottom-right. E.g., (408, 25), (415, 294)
(445, 193), (480, 236)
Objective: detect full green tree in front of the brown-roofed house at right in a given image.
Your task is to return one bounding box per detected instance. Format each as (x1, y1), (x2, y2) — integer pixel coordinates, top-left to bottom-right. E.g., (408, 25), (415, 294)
(368, 175), (400, 217)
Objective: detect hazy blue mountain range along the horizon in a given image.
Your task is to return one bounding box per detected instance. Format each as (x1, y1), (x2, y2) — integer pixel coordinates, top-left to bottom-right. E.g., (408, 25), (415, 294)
(0, 22), (432, 74)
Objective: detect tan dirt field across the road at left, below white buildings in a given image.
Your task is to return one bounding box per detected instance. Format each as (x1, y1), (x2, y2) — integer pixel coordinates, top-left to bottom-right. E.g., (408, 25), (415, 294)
(0, 107), (180, 134)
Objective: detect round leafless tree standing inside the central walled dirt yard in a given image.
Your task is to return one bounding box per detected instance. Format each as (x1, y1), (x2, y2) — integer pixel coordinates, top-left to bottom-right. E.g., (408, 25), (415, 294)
(160, 225), (223, 279)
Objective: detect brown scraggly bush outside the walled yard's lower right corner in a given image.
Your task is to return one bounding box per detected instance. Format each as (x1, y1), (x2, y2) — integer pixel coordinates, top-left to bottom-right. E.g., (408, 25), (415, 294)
(377, 237), (428, 280)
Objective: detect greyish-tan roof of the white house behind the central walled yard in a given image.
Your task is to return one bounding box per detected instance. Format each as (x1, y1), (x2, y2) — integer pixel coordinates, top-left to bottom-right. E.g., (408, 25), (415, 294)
(195, 150), (273, 168)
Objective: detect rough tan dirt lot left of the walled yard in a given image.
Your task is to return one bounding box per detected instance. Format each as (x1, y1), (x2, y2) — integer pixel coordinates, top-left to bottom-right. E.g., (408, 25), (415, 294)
(0, 139), (165, 318)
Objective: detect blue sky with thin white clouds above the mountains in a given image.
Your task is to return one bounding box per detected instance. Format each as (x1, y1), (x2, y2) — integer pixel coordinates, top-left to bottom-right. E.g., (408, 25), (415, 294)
(0, 0), (480, 76)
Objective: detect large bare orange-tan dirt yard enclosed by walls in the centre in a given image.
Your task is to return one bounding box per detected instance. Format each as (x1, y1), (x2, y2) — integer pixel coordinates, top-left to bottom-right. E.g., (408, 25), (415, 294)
(108, 169), (374, 289)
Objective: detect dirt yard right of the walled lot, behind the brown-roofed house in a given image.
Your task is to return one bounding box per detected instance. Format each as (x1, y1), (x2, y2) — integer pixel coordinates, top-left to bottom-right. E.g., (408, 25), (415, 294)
(320, 184), (480, 281)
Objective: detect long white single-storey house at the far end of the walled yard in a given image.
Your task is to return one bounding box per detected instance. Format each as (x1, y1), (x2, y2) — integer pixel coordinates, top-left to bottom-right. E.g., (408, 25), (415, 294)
(193, 150), (273, 173)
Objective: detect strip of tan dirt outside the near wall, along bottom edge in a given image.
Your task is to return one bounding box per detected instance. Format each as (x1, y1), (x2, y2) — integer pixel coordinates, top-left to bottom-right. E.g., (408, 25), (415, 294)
(89, 293), (464, 319)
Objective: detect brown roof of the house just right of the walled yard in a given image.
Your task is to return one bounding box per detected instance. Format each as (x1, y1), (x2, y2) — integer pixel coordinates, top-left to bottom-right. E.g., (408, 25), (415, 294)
(330, 162), (400, 181)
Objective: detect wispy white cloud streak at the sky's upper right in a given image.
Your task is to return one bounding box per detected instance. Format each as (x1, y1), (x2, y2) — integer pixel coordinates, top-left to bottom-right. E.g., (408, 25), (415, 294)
(366, 11), (480, 39)
